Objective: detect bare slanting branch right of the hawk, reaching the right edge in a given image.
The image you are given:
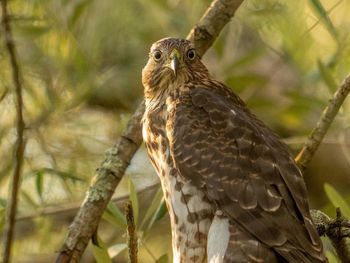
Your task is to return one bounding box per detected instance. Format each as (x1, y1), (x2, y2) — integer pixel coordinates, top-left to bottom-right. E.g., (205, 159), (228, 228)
(296, 75), (350, 171)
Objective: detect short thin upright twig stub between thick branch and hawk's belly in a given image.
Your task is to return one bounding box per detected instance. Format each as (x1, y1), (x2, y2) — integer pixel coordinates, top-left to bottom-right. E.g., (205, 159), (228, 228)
(125, 201), (138, 263)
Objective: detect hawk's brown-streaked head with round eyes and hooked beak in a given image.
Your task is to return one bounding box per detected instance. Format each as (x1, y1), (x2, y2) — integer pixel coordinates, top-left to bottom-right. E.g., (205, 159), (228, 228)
(142, 38), (208, 97)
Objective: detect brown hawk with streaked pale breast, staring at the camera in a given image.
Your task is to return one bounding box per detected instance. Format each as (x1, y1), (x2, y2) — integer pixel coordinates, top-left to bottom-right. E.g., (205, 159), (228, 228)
(142, 38), (327, 263)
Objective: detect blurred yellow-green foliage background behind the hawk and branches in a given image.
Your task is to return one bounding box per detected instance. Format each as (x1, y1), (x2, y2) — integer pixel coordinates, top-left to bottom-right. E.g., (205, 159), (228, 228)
(0, 0), (350, 263)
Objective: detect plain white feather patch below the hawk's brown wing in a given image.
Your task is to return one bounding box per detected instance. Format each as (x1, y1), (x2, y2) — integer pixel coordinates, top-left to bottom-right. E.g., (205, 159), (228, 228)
(207, 215), (230, 263)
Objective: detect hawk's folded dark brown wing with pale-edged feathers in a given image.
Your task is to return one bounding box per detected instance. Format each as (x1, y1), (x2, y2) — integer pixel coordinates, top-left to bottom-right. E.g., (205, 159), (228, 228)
(166, 84), (325, 262)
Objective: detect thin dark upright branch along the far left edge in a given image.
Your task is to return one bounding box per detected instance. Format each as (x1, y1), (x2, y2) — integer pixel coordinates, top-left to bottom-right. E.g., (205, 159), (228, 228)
(1, 0), (25, 263)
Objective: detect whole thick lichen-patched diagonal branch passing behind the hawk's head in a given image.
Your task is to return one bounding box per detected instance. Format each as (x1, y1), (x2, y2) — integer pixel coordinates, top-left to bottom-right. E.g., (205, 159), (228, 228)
(56, 0), (243, 263)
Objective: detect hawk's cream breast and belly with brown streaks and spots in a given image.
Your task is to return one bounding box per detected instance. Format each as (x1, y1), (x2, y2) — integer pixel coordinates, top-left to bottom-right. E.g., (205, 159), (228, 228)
(142, 102), (214, 263)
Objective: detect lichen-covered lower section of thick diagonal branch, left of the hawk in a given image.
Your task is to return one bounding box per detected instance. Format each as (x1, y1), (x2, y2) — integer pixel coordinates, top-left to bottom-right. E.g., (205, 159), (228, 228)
(56, 103), (144, 262)
